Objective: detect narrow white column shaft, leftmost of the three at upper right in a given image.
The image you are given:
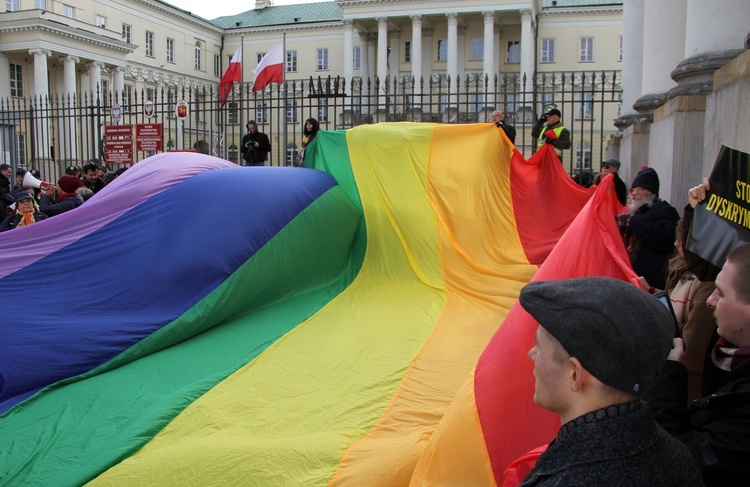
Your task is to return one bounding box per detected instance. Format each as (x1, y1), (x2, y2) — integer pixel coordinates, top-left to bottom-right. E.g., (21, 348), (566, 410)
(621, 0), (645, 115)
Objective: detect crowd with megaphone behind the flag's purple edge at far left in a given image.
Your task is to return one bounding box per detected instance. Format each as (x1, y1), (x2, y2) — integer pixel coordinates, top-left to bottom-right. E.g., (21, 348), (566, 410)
(0, 161), (127, 232)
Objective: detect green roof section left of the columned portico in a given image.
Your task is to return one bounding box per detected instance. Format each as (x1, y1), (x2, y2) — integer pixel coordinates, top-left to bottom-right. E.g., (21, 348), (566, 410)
(211, 1), (344, 29)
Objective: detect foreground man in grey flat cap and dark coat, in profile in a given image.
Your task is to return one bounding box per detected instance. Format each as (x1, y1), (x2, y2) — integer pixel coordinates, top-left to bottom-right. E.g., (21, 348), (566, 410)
(519, 277), (703, 487)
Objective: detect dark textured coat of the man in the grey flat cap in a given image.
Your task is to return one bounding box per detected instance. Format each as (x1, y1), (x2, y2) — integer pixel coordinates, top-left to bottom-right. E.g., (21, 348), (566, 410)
(521, 402), (703, 487)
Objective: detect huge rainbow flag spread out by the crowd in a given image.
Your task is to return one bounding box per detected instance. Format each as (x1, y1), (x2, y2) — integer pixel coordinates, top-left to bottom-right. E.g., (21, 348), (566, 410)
(0, 123), (635, 486)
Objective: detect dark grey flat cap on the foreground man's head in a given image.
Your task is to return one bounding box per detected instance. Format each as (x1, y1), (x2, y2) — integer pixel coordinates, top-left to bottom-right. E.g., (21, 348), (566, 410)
(519, 277), (674, 396)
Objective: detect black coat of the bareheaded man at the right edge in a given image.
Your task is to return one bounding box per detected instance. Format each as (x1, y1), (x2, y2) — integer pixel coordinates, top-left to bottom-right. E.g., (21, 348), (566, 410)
(644, 360), (750, 486)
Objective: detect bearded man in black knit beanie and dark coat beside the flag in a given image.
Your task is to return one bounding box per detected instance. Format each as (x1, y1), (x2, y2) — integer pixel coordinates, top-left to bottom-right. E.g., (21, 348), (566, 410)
(615, 167), (680, 289)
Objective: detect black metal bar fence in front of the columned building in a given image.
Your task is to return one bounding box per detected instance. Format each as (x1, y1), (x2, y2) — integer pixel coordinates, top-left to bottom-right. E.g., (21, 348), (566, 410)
(0, 71), (622, 186)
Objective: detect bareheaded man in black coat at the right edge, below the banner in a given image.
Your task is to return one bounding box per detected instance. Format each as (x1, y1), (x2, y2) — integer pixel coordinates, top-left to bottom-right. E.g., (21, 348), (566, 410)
(644, 230), (750, 486)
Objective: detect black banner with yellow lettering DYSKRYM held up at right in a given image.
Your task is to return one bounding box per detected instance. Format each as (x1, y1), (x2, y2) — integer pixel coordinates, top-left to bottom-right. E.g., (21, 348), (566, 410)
(687, 146), (750, 267)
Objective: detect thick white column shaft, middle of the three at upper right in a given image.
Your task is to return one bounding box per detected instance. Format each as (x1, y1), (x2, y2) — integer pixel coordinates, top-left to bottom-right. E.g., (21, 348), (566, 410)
(639, 0), (684, 104)
